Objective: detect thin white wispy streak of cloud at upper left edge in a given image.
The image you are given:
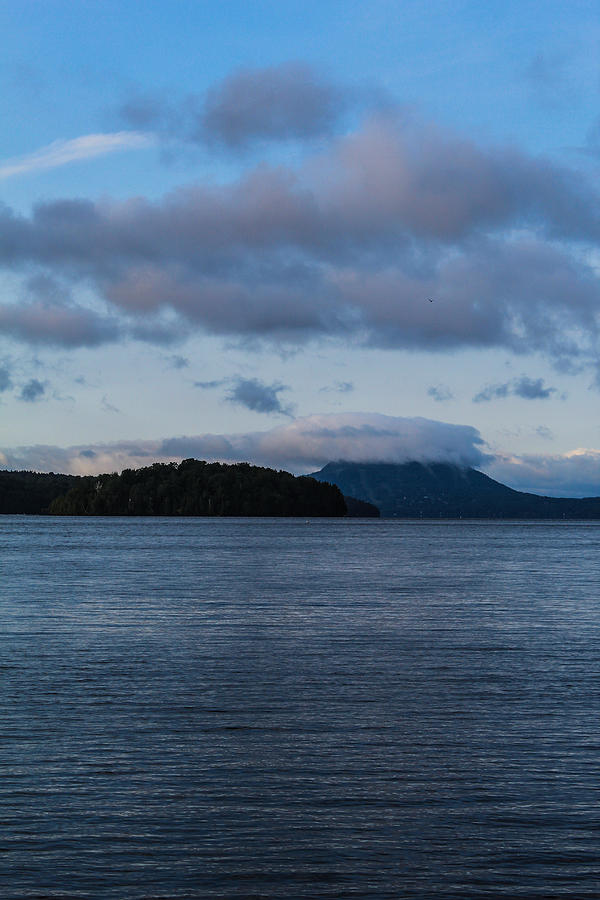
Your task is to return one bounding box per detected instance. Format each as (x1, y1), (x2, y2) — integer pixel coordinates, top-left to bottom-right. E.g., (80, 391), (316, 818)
(0, 131), (156, 181)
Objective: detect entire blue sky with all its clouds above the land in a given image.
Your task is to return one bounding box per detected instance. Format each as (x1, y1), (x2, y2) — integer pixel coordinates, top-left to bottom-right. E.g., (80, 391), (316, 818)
(0, 0), (600, 496)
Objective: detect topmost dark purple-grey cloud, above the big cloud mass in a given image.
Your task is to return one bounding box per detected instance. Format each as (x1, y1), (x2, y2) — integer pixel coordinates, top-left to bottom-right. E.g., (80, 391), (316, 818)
(120, 62), (350, 151)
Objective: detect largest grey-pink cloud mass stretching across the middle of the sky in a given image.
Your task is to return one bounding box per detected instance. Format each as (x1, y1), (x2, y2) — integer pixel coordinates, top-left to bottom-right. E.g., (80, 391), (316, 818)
(0, 102), (600, 368)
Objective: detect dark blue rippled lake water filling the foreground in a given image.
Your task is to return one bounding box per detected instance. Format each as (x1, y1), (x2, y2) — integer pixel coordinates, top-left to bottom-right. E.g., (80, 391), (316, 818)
(0, 517), (600, 900)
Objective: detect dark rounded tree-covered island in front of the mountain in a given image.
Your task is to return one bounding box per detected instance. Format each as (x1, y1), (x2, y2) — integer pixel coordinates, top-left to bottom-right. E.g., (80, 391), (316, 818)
(47, 459), (346, 516)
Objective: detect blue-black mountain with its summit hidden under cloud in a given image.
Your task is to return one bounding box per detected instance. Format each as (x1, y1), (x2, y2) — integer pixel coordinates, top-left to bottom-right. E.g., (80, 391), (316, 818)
(311, 462), (600, 519)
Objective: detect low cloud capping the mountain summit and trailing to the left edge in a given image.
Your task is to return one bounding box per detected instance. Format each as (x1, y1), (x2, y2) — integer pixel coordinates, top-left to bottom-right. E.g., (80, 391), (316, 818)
(3, 413), (488, 474)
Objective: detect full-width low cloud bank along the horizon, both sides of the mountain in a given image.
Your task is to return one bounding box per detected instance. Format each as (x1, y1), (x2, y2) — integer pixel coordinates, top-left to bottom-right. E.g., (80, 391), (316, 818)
(0, 413), (600, 497)
